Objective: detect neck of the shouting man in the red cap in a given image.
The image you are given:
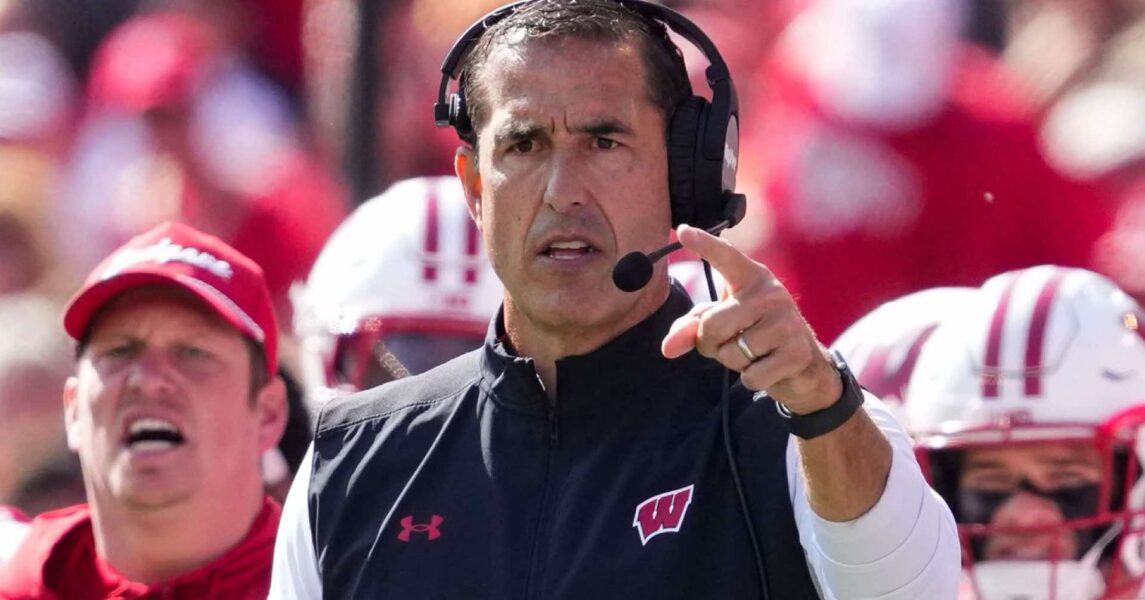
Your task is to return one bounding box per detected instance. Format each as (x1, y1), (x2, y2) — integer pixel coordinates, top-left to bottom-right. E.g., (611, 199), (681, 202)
(89, 488), (262, 585)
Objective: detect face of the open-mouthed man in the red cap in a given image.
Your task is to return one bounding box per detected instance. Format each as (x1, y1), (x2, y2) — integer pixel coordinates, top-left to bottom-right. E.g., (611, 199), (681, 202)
(64, 289), (285, 511)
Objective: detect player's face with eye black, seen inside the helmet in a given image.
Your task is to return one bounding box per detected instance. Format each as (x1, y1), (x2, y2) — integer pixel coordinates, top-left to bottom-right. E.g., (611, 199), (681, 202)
(958, 443), (1101, 560)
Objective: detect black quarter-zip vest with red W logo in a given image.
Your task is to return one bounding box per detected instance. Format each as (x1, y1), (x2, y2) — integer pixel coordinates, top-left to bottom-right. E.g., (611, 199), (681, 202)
(309, 289), (816, 600)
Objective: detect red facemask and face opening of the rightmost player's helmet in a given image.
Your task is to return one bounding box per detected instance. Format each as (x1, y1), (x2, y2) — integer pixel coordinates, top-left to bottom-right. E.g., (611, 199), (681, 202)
(917, 415), (1145, 600)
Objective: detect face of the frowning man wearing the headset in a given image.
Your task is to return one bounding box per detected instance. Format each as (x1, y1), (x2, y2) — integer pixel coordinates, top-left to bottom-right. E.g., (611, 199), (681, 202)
(463, 39), (671, 343)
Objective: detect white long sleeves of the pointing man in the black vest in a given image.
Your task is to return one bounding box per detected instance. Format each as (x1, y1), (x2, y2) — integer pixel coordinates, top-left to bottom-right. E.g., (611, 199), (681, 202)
(270, 394), (961, 600)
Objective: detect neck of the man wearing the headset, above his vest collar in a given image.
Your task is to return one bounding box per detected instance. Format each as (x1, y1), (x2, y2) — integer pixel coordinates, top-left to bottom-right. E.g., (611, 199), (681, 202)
(505, 277), (669, 401)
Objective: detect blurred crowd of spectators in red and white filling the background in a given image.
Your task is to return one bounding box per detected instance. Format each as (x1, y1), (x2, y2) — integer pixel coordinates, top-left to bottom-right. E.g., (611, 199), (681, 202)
(0, 0), (1145, 522)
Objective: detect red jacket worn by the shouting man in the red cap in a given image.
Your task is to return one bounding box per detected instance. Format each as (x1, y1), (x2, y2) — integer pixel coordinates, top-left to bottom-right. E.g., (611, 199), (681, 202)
(0, 498), (282, 600)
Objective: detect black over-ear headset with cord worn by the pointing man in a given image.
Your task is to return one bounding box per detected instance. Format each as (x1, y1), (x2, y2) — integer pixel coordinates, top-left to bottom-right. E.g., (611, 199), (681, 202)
(433, 0), (769, 600)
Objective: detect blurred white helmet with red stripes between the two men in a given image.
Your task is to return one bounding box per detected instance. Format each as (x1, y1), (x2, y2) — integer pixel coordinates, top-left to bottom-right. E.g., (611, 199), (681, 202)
(291, 176), (504, 405)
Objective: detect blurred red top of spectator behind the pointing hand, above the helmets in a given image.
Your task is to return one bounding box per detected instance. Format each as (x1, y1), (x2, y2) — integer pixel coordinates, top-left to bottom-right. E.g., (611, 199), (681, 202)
(756, 48), (1113, 342)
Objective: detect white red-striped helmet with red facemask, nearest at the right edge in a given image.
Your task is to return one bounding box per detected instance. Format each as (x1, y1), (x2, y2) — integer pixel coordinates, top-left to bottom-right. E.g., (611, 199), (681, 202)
(905, 266), (1145, 600)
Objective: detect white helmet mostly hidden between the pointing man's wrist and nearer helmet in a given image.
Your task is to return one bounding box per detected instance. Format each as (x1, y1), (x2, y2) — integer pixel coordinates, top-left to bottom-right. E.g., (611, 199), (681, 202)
(831, 287), (978, 423)
